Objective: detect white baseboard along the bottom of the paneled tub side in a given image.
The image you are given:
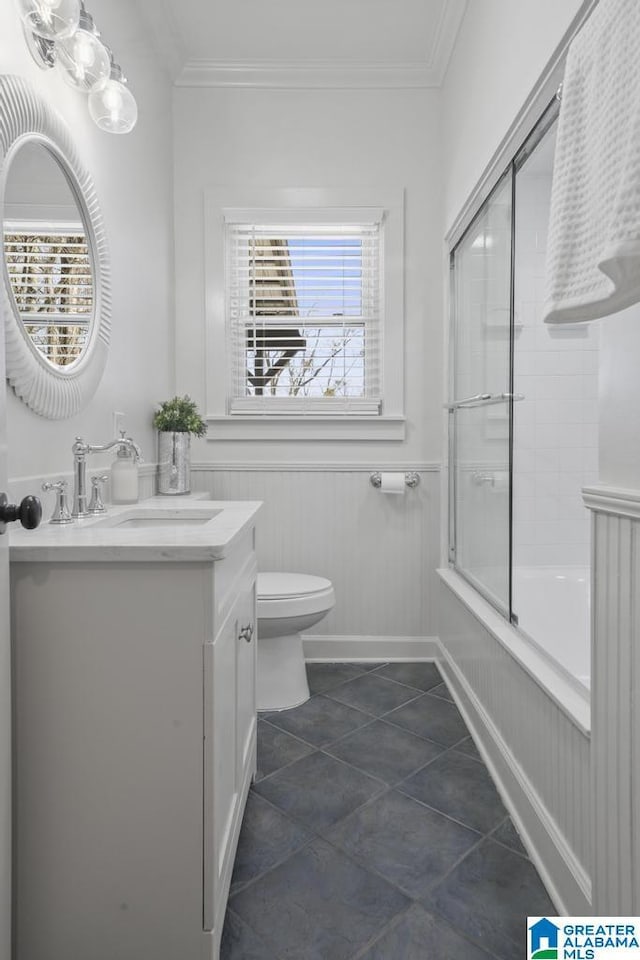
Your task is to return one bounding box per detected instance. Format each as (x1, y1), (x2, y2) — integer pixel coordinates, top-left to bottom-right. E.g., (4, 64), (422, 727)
(438, 644), (591, 916)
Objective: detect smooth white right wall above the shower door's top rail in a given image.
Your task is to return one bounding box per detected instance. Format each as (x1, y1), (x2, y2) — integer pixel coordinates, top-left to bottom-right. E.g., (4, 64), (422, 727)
(442, 0), (582, 228)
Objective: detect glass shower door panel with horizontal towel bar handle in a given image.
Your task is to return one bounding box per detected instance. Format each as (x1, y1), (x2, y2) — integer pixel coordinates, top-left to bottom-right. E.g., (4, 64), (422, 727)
(448, 170), (512, 617)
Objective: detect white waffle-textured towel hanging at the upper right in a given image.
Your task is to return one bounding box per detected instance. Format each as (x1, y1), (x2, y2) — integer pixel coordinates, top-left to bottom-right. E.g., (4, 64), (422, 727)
(544, 0), (640, 323)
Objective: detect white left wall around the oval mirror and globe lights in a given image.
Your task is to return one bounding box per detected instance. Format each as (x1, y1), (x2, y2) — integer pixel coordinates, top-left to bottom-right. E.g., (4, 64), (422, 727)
(0, 0), (173, 492)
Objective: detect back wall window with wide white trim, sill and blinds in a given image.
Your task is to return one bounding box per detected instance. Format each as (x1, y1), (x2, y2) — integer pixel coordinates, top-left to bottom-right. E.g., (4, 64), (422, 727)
(205, 187), (404, 440)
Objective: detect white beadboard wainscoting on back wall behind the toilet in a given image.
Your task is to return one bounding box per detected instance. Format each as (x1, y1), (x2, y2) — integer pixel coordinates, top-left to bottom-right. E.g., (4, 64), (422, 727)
(191, 463), (440, 640)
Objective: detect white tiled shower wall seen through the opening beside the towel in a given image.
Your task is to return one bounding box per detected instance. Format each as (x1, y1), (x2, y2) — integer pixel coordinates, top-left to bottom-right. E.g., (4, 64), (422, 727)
(513, 168), (598, 566)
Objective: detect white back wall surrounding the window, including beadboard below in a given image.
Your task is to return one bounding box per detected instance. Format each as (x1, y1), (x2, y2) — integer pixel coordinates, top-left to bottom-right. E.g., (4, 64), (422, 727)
(174, 88), (442, 636)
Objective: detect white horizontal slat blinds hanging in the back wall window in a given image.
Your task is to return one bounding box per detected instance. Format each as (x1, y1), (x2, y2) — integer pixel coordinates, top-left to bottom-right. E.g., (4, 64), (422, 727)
(226, 221), (382, 416)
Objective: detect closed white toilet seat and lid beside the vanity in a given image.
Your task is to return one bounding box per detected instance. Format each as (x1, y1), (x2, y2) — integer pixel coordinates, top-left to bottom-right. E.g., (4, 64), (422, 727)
(257, 573), (335, 620)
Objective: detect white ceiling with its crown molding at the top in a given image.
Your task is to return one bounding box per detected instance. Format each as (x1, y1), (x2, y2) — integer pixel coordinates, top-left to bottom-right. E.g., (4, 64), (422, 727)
(138, 0), (467, 86)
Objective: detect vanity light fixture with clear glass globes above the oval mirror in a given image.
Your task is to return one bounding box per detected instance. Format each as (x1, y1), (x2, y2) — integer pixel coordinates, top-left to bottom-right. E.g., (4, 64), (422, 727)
(15, 0), (138, 133)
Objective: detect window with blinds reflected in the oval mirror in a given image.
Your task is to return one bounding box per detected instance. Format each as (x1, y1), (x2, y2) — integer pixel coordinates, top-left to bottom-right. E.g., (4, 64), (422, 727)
(4, 222), (93, 366)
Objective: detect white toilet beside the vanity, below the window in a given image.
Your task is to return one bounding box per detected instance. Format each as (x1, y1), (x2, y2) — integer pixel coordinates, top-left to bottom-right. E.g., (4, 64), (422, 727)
(257, 573), (336, 710)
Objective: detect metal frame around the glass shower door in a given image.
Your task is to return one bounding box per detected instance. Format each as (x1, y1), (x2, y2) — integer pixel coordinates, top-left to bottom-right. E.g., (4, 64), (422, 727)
(445, 95), (561, 626)
